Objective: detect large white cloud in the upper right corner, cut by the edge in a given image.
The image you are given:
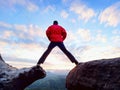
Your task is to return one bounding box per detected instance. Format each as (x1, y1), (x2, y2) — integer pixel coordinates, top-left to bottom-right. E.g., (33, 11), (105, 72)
(99, 2), (120, 27)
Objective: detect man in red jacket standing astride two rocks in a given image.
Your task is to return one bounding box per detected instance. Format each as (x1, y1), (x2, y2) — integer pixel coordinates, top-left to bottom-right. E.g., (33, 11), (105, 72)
(37, 21), (78, 65)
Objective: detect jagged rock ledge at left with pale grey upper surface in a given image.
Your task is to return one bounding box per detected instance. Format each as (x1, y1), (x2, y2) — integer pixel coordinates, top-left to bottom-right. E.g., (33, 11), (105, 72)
(0, 56), (46, 90)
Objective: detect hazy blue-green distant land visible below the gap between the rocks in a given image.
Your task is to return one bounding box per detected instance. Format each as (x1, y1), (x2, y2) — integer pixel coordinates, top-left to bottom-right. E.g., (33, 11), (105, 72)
(25, 72), (67, 90)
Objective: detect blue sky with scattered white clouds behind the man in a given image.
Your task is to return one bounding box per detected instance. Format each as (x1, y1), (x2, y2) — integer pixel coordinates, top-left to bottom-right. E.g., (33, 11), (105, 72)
(0, 0), (120, 70)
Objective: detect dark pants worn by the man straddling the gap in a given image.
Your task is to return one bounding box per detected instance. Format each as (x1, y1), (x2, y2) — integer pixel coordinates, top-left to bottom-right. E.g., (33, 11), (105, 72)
(37, 42), (77, 64)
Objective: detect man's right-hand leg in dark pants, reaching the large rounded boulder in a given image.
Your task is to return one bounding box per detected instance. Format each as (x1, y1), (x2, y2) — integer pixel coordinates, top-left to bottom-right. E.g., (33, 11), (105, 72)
(57, 42), (78, 65)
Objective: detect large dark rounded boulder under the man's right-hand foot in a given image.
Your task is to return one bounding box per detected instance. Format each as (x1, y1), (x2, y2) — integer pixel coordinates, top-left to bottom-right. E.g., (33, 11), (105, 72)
(66, 58), (120, 90)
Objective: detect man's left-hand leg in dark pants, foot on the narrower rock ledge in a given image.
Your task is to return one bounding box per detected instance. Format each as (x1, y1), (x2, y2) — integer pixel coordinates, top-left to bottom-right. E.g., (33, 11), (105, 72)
(37, 42), (55, 64)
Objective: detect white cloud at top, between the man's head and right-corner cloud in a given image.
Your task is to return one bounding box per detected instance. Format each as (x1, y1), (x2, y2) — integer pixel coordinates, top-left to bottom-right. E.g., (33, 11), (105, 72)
(70, 2), (95, 22)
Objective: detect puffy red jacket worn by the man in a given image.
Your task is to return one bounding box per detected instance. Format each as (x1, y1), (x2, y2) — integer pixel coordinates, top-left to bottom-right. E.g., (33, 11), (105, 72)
(46, 25), (67, 42)
